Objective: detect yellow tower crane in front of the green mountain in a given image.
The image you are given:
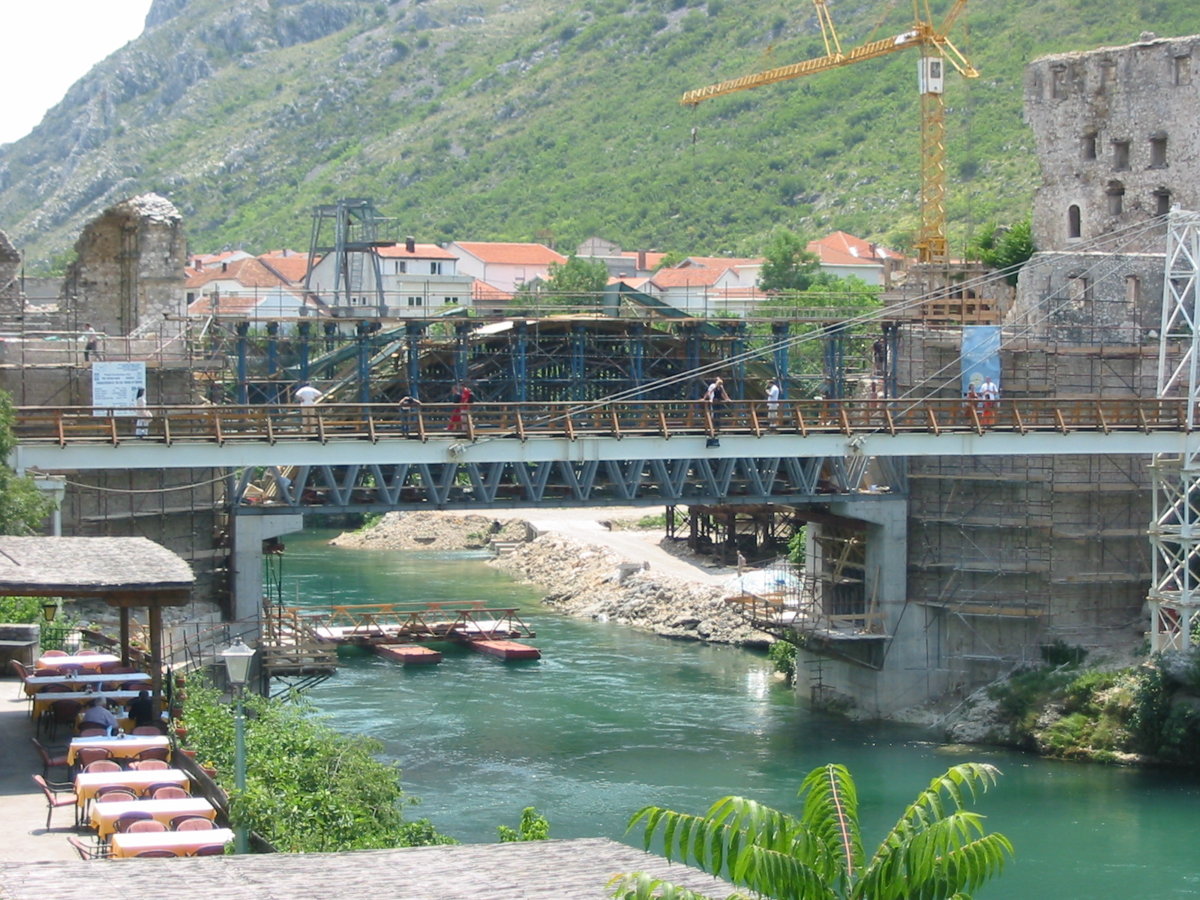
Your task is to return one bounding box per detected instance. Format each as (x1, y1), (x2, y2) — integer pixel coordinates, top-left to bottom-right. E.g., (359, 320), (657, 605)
(679, 0), (979, 265)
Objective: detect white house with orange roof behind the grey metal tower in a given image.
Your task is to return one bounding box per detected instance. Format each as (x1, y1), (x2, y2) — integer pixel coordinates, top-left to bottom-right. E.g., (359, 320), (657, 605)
(308, 240), (475, 318)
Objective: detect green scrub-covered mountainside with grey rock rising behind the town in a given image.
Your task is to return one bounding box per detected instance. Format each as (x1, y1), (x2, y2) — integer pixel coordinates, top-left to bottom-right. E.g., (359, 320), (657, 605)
(0, 0), (1200, 264)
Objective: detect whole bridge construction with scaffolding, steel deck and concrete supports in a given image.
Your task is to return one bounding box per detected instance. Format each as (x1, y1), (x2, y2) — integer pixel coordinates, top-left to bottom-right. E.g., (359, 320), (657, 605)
(6, 213), (1196, 713)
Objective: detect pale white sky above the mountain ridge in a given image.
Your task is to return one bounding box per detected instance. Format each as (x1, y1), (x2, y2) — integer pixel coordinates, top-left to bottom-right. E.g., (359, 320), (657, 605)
(0, 0), (151, 144)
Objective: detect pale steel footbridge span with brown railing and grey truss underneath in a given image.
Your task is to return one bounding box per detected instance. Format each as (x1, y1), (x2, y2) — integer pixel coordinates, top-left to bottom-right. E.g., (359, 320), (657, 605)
(13, 398), (1200, 515)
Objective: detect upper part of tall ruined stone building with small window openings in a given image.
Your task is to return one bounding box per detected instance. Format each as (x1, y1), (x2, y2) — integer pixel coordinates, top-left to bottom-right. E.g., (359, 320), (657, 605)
(1025, 35), (1200, 252)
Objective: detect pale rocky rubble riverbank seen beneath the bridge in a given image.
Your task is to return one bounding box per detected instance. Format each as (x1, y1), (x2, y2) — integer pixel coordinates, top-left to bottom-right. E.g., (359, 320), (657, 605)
(331, 512), (772, 646)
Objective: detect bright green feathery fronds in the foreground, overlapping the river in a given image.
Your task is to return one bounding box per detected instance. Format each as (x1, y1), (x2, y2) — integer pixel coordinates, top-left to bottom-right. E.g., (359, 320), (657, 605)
(612, 762), (1013, 900)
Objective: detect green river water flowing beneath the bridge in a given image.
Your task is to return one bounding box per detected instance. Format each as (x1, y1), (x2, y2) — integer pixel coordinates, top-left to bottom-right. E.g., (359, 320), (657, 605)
(284, 532), (1200, 900)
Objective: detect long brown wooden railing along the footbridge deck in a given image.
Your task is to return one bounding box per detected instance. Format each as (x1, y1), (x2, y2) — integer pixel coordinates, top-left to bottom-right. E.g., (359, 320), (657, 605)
(13, 397), (1187, 445)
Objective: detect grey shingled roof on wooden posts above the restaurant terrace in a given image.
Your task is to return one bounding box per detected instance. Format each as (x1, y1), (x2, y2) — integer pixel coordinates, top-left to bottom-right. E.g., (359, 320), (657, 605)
(0, 535), (196, 702)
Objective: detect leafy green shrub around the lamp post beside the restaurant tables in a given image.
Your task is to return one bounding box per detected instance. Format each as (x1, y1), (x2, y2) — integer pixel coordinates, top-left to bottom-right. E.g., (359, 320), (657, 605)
(185, 679), (455, 852)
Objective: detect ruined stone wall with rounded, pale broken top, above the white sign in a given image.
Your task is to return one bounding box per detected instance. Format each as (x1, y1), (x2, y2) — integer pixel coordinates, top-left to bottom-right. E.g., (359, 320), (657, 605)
(66, 193), (187, 335)
